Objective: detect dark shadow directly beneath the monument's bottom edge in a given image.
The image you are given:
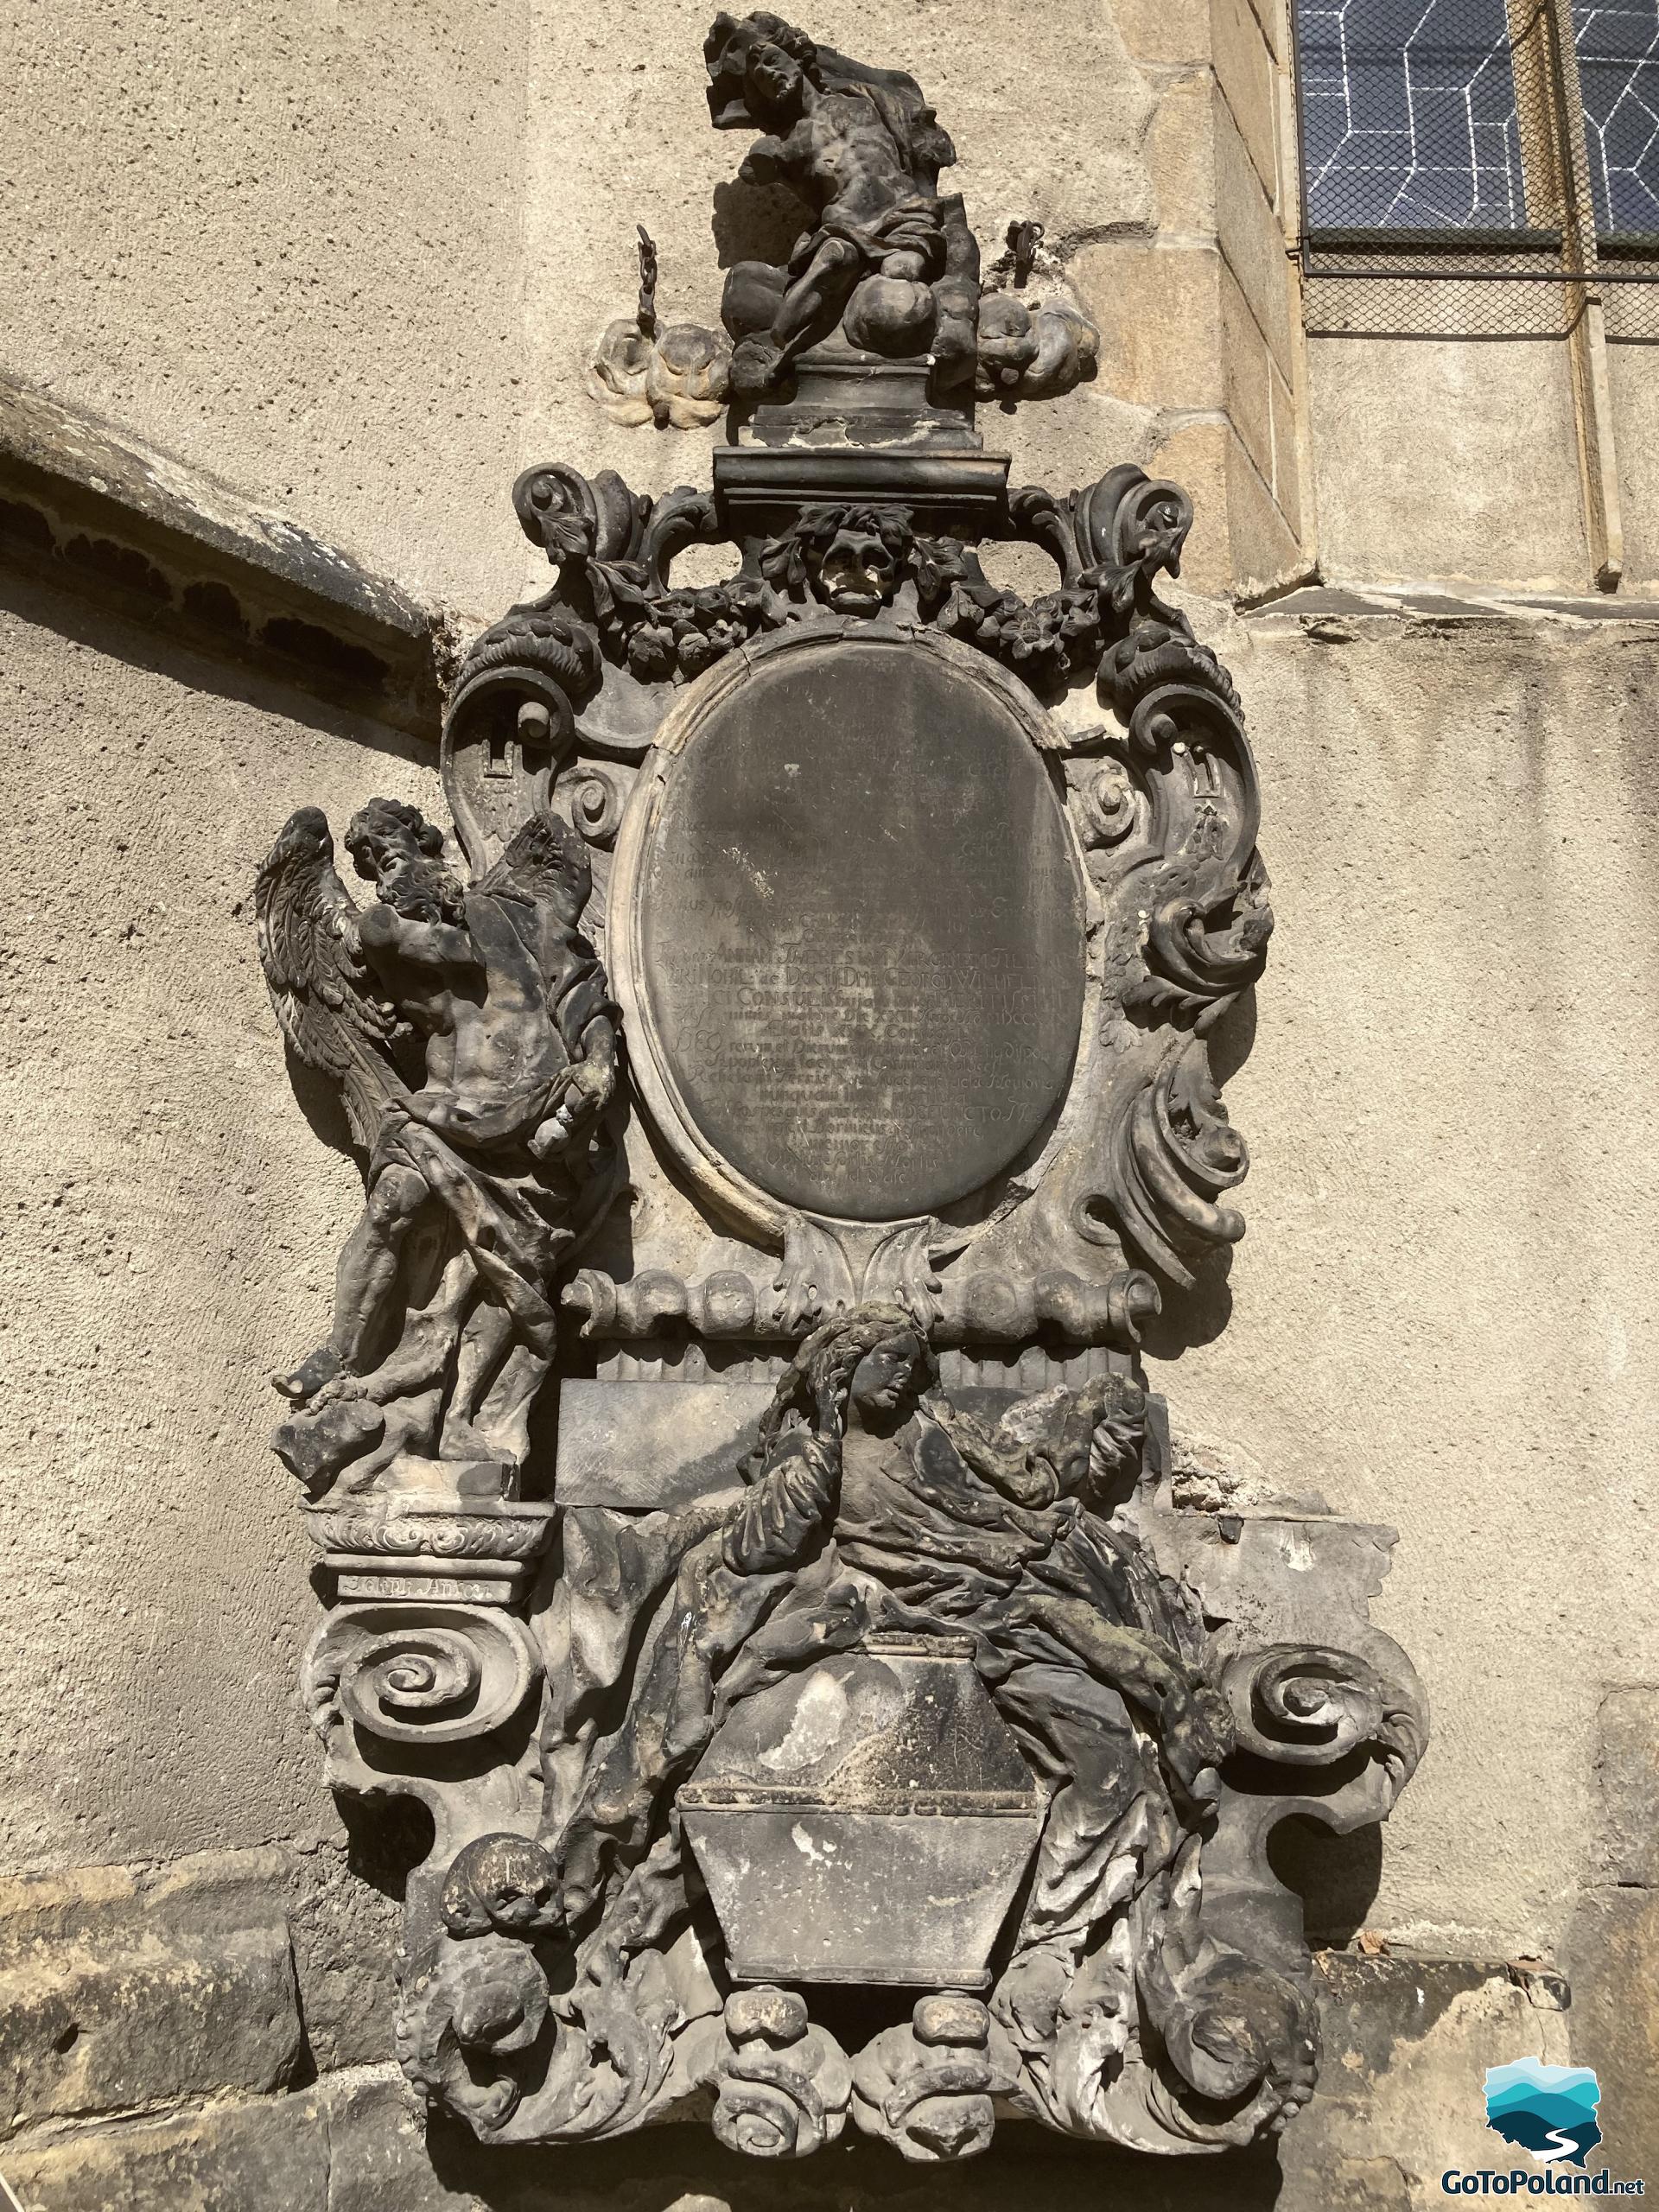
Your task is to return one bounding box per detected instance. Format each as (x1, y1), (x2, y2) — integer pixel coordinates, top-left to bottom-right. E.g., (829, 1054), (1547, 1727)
(427, 2121), (1283, 2212)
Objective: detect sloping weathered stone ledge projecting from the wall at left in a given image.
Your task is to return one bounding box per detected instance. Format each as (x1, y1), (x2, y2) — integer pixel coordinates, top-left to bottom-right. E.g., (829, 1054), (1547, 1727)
(0, 378), (451, 741)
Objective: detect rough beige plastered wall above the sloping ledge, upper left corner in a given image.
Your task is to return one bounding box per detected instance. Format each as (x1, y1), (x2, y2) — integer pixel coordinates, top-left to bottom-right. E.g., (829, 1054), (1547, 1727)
(0, 0), (531, 611)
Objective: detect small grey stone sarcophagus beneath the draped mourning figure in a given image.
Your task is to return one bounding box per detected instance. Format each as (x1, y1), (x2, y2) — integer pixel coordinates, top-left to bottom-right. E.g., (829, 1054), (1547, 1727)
(679, 1635), (1048, 1988)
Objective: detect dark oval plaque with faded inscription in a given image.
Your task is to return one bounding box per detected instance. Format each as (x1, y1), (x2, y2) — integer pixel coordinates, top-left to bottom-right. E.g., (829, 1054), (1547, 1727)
(639, 632), (1084, 1221)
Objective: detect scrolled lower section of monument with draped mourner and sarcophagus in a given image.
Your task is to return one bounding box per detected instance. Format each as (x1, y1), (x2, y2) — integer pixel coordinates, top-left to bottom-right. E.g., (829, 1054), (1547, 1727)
(308, 1344), (1425, 2161)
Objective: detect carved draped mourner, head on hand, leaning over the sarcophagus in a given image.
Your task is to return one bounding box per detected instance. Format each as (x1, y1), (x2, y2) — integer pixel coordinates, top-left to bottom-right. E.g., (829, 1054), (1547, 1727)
(528, 1307), (1305, 2148)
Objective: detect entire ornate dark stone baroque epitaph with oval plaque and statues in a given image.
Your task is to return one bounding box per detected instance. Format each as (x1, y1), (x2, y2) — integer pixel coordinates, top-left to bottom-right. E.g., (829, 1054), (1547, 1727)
(259, 16), (1427, 2161)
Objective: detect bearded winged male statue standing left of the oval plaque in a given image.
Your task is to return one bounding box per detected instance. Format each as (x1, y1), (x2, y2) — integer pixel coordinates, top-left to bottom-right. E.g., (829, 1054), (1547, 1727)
(257, 798), (617, 1496)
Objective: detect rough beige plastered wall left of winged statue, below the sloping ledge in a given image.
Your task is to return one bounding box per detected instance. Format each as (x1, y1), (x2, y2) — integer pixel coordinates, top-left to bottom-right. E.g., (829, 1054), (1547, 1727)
(0, 577), (435, 1869)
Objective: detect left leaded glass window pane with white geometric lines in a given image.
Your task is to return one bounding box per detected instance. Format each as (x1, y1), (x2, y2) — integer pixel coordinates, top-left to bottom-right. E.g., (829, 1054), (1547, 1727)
(1296, 0), (1530, 230)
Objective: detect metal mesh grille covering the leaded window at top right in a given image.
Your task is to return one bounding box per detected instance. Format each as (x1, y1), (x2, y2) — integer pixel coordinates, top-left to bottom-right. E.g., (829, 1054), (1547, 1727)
(1296, 0), (1659, 340)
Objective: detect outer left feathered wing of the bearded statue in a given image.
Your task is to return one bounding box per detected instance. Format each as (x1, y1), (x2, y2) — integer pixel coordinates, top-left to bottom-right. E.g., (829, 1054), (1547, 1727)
(254, 807), (410, 1146)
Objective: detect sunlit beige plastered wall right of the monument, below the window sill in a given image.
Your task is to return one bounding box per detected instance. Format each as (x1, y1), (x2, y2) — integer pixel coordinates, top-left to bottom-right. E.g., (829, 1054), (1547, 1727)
(1166, 600), (1659, 1955)
